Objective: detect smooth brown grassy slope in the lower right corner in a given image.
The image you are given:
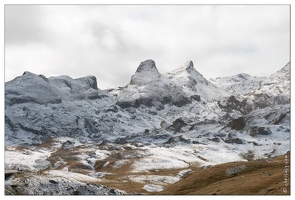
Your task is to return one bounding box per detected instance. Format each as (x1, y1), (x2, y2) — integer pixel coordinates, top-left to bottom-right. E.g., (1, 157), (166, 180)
(157, 155), (290, 195)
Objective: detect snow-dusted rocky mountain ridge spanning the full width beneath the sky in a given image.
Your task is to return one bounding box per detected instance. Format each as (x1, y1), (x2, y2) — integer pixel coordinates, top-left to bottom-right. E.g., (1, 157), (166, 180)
(5, 60), (290, 155)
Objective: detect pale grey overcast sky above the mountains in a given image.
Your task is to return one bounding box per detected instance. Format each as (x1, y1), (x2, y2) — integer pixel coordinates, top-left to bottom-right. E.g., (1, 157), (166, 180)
(4, 5), (290, 89)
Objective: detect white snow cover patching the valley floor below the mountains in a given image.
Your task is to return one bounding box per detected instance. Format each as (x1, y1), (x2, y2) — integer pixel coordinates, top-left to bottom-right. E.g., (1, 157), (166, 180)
(5, 130), (290, 195)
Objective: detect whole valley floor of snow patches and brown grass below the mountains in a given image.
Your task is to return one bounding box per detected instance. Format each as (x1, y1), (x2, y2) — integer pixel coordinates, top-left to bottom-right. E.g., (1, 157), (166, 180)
(5, 137), (290, 195)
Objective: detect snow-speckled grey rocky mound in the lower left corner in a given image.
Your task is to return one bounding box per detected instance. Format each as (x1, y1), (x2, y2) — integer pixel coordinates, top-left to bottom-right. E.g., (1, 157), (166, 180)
(5, 173), (128, 195)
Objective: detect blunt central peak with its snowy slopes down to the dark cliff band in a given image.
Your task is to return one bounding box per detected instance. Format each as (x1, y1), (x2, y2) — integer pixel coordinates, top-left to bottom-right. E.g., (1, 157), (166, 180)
(111, 60), (191, 110)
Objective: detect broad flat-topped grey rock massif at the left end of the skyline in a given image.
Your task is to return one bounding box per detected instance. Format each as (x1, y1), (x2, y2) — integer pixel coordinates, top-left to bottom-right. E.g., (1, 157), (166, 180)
(5, 72), (106, 106)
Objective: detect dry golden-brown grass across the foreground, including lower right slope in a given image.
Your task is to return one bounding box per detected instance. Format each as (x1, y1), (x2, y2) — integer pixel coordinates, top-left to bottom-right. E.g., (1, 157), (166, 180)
(42, 138), (290, 195)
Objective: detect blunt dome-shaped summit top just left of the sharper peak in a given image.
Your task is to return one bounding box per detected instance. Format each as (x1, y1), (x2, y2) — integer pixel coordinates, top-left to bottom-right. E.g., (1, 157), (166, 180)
(130, 60), (161, 86)
